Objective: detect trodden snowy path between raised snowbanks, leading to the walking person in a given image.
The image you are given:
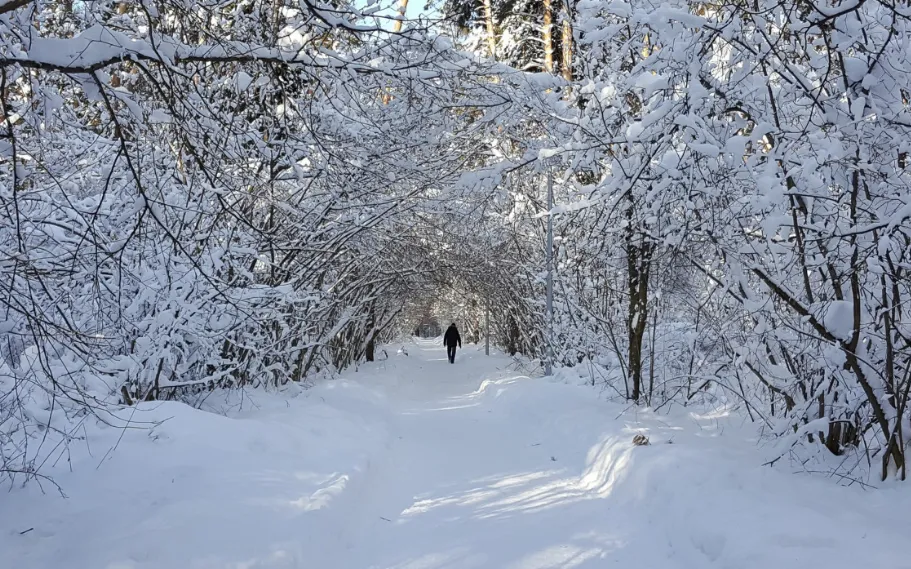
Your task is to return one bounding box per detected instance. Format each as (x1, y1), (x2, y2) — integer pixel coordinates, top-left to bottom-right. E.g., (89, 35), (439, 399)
(340, 345), (640, 569)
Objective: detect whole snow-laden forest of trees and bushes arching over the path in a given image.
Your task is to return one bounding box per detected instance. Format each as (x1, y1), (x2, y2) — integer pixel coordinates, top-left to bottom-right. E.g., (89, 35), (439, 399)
(0, 0), (911, 492)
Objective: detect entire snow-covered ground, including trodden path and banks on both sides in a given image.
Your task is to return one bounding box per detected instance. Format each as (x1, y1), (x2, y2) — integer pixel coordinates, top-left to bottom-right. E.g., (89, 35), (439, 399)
(0, 342), (911, 569)
